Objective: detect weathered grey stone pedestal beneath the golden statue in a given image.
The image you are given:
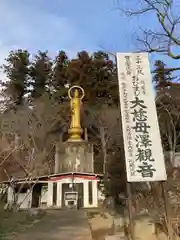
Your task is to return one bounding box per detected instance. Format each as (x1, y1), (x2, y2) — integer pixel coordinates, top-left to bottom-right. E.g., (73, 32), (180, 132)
(55, 141), (94, 173)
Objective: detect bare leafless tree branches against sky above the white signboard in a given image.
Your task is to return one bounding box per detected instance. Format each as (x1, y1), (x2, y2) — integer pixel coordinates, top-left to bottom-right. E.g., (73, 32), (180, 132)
(118, 0), (180, 60)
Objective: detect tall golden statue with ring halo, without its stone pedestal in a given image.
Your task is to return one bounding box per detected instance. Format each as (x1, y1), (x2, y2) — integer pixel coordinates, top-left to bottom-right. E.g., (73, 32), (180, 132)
(68, 86), (84, 141)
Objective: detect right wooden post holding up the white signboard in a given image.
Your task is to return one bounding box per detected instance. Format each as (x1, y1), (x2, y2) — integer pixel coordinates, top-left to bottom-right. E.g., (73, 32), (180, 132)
(161, 181), (173, 240)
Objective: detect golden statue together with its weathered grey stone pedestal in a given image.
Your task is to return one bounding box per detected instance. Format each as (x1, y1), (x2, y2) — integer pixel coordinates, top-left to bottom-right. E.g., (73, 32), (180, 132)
(55, 86), (94, 173)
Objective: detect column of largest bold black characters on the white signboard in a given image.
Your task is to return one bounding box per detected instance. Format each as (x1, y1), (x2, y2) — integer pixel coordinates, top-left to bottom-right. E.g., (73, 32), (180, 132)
(130, 95), (156, 178)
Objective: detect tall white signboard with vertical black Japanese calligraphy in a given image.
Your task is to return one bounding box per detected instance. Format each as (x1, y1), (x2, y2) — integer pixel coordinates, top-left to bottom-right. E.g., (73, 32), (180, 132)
(117, 53), (167, 182)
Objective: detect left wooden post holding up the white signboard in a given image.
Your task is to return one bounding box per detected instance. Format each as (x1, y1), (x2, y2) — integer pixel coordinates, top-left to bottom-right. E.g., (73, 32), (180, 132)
(126, 182), (135, 240)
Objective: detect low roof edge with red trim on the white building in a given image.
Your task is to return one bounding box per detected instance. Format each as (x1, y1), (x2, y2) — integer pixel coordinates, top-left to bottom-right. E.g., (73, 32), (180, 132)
(0, 172), (103, 184)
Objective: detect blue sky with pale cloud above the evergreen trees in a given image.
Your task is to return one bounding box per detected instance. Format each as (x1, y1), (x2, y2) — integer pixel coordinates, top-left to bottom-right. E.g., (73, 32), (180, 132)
(0, 0), (179, 80)
